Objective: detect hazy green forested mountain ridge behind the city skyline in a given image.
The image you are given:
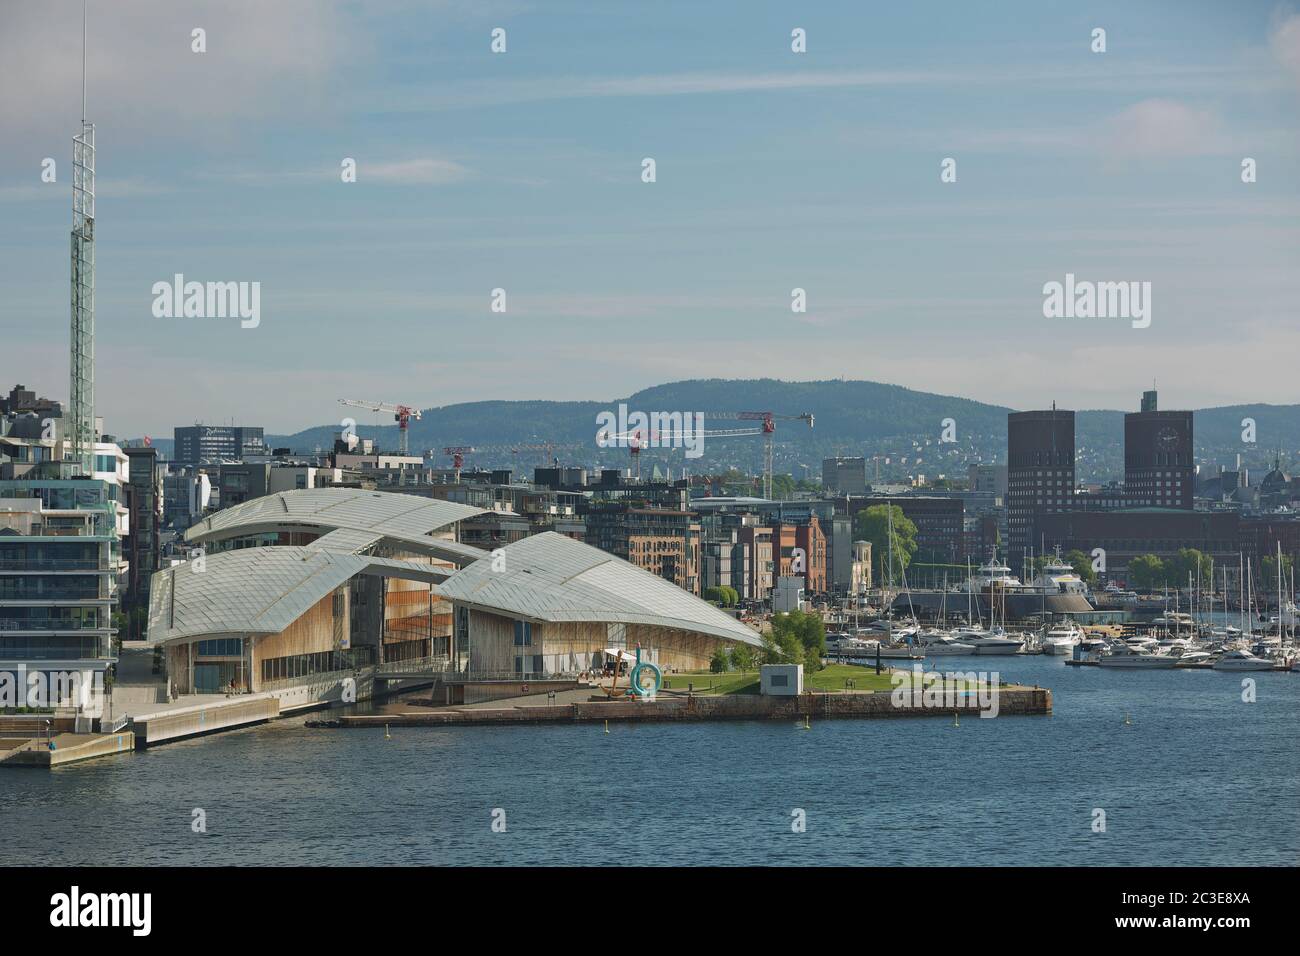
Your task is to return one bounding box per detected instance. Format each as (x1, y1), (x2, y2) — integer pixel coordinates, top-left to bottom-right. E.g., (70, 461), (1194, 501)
(267, 378), (1300, 480)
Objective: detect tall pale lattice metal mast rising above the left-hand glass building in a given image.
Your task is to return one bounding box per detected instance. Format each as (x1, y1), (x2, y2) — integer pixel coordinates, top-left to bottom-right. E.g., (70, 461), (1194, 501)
(68, 3), (95, 475)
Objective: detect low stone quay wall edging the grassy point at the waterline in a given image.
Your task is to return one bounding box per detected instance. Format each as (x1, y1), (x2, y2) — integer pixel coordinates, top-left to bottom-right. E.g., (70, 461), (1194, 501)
(317, 687), (1052, 727)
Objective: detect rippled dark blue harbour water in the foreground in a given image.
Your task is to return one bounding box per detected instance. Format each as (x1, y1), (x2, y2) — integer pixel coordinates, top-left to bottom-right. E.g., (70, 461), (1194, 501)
(0, 657), (1300, 865)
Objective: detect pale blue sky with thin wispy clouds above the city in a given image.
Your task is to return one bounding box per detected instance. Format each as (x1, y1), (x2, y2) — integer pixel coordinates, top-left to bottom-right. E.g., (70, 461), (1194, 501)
(0, 0), (1300, 437)
